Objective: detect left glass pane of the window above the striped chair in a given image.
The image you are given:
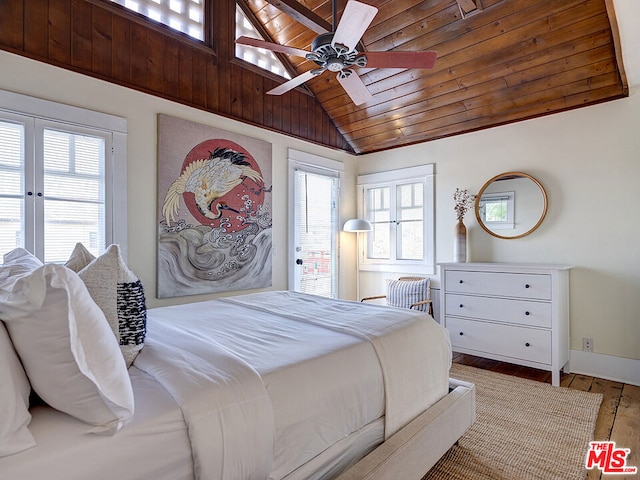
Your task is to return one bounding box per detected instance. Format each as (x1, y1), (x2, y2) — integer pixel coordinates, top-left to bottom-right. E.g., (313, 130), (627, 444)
(366, 187), (391, 259)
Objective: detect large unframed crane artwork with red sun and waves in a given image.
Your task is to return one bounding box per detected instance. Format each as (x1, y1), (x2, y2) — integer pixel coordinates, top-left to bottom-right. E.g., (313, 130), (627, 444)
(157, 115), (273, 298)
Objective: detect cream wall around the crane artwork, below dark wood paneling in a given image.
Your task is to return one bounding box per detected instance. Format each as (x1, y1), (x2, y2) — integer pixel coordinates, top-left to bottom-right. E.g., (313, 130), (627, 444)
(0, 51), (356, 307)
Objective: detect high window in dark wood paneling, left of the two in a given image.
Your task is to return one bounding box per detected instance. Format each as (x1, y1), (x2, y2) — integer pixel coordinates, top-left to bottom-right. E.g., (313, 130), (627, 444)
(111, 0), (205, 41)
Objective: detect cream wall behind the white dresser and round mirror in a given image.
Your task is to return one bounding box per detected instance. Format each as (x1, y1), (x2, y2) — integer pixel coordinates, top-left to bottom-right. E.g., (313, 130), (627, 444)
(358, 92), (640, 366)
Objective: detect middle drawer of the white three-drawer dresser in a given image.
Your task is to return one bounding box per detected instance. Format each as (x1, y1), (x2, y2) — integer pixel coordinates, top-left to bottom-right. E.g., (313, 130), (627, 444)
(445, 293), (551, 328)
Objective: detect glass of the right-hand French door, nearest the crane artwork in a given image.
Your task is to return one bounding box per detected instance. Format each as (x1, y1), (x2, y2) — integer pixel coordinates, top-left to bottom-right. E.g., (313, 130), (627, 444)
(43, 129), (105, 262)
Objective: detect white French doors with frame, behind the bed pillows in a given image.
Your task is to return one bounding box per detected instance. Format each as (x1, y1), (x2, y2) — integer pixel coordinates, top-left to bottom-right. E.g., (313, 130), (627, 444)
(0, 91), (126, 262)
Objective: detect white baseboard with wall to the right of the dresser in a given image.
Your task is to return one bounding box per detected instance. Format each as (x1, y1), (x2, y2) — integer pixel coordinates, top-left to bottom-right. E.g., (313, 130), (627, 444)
(569, 350), (640, 386)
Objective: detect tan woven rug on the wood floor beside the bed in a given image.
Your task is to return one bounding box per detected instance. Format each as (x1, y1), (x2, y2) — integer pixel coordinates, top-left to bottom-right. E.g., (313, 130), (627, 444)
(423, 364), (602, 480)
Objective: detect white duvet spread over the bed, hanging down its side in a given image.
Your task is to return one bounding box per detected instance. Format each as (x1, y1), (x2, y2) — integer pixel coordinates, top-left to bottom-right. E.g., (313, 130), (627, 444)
(135, 292), (451, 480)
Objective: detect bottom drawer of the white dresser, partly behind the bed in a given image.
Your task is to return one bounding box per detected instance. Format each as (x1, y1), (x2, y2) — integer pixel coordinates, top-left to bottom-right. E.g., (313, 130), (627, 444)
(445, 317), (551, 365)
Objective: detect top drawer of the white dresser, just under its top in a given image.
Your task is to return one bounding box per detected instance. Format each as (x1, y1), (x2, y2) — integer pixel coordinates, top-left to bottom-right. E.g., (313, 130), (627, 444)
(445, 270), (551, 300)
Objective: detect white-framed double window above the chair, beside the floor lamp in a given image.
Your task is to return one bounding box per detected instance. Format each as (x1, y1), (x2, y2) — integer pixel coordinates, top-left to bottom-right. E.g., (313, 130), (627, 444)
(358, 165), (434, 274)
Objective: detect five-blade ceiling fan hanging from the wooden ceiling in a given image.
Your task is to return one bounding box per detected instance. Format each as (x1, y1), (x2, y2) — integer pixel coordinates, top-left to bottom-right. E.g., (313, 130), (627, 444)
(236, 0), (437, 105)
